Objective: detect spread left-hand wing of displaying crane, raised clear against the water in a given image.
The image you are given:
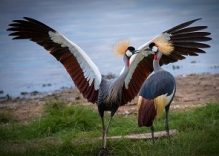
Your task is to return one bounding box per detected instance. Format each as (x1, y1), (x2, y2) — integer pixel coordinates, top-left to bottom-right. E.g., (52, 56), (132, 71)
(8, 17), (102, 103)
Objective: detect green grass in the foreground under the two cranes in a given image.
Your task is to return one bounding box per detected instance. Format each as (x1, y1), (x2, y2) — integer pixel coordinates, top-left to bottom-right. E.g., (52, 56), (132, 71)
(0, 101), (219, 156)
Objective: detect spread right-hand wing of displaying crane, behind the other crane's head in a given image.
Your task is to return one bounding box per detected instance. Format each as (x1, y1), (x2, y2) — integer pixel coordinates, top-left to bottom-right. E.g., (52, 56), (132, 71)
(122, 19), (211, 105)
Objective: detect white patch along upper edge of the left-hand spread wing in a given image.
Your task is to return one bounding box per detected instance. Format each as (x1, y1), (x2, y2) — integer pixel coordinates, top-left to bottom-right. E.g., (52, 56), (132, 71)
(48, 31), (101, 90)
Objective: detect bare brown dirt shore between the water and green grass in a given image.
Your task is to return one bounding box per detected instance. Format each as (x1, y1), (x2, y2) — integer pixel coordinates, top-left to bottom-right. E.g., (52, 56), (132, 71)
(0, 74), (219, 122)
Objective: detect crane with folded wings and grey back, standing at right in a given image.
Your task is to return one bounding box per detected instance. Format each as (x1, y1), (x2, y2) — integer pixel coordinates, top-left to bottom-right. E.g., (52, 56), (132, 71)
(138, 47), (176, 142)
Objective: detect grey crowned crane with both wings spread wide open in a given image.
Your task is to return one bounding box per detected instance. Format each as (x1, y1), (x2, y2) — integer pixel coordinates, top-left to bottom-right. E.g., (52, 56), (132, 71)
(8, 17), (210, 154)
